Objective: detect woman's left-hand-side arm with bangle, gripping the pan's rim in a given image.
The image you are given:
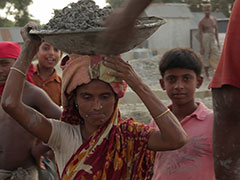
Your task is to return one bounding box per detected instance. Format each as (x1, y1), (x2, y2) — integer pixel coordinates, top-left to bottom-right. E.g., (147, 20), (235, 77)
(1, 23), (52, 143)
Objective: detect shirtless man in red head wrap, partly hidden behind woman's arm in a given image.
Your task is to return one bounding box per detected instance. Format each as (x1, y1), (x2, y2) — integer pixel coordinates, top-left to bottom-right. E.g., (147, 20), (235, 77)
(0, 41), (61, 180)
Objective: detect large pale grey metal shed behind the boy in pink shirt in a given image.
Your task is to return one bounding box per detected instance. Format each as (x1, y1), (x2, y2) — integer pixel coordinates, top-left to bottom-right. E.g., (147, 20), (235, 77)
(145, 3), (193, 52)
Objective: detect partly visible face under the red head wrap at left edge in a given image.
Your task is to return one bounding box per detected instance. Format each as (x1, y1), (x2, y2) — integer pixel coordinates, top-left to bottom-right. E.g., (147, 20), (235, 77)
(0, 58), (16, 84)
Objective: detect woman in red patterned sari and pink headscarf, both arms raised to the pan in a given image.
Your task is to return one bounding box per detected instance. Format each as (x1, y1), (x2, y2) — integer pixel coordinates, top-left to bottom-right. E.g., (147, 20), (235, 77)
(2, 24), (187, 180)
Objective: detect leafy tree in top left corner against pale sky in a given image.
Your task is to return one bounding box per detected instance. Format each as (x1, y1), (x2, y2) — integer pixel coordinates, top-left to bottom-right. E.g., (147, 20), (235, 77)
(0, 0), (32, 27)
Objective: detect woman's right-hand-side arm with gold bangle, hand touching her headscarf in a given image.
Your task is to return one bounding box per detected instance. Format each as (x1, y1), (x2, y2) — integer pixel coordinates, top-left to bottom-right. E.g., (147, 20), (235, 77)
(104, 57), (187, 151)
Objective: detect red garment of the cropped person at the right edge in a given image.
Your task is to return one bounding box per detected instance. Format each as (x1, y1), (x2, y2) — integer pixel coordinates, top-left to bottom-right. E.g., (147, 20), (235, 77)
(209, 0), (240, 88)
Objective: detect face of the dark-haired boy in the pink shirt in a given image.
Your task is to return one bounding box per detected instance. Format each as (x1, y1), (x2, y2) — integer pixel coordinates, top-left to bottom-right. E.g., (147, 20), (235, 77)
(160, 68), (203, 105)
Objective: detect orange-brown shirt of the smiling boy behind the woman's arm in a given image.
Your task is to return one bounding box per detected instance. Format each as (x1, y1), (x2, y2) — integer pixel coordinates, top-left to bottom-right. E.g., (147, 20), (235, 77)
(32, 65), (62, 106)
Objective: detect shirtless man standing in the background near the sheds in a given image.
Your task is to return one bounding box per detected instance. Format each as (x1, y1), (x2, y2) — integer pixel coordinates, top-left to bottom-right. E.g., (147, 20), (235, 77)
(198, 4), (220, 80)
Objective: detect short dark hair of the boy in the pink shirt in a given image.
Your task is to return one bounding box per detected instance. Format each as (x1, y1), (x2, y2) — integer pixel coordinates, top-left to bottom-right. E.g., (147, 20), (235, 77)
(159, 48), (203, 77)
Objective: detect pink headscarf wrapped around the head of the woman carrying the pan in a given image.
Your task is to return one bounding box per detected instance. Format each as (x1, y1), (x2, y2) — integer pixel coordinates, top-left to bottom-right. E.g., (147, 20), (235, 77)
(61, 54), (127, 124)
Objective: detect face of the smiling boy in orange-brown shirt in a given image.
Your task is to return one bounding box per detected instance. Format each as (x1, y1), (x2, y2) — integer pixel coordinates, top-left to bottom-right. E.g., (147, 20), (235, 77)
(37, 42), (62, 68)
